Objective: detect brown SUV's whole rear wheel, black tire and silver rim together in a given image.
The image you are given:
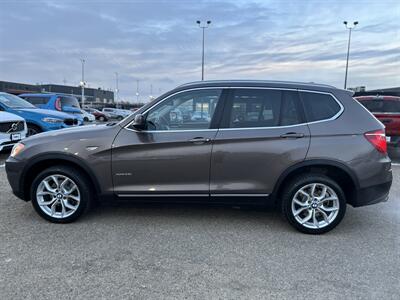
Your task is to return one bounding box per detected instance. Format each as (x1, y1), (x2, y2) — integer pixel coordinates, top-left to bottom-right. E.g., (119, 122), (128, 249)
(281, 174), (346, 234)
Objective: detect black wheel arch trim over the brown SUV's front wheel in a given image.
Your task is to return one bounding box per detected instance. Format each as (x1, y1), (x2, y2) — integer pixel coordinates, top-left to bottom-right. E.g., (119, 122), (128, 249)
(20, 153), (101, 200)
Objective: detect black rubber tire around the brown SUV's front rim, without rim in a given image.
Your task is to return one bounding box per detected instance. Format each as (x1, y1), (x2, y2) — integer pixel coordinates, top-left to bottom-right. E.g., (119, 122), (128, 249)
(30, 166), (92, 223)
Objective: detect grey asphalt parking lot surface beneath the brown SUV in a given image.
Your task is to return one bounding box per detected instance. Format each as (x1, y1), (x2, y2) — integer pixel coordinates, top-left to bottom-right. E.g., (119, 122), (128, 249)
(0, 154), (400, 299)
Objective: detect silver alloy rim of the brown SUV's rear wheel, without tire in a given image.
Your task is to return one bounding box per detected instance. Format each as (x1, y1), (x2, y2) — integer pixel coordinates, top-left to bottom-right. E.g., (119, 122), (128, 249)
(291, 183), (340, 229)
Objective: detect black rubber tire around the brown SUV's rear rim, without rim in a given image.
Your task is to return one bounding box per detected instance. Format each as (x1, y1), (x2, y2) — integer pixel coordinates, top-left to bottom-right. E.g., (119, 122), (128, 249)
(282, 174), (346, 234)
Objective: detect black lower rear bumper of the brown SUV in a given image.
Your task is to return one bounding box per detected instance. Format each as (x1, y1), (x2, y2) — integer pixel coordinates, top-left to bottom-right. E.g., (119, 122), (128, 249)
(350, 180), (392, 207)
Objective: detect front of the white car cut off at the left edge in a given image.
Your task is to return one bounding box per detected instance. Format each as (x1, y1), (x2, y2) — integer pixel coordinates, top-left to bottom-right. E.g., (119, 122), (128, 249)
(0, 111), (28, 151)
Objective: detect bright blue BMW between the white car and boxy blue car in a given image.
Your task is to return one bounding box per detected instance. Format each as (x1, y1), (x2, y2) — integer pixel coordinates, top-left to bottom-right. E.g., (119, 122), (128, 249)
(0, 92), (82, 136)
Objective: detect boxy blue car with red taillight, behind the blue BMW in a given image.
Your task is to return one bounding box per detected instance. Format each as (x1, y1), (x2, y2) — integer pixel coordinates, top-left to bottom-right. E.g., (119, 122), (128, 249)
(19, 93), (84, 123)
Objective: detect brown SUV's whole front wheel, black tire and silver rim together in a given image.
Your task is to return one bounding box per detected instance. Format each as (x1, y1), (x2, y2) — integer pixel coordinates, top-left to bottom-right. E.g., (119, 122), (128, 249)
(30, 165), (93, 223)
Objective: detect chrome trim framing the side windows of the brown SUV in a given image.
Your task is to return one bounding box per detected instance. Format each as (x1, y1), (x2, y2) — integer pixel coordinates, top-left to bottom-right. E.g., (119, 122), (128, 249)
(124, 86), (344, 133)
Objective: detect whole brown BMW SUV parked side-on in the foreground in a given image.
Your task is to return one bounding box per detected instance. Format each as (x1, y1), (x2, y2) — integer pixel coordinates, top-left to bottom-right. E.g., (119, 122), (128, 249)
(6, 81), (392, 233)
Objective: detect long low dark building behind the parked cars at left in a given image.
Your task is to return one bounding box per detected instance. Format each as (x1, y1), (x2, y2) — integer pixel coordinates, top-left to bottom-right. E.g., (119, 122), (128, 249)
(0, 81), (114, 107)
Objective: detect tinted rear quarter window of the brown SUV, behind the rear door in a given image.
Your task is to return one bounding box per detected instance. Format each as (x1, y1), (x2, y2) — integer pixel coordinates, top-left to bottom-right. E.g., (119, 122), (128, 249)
(300, 92), (341, 122)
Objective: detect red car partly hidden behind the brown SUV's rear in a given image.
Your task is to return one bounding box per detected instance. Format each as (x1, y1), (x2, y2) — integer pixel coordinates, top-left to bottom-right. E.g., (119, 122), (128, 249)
(355, 96), (400, 144)
